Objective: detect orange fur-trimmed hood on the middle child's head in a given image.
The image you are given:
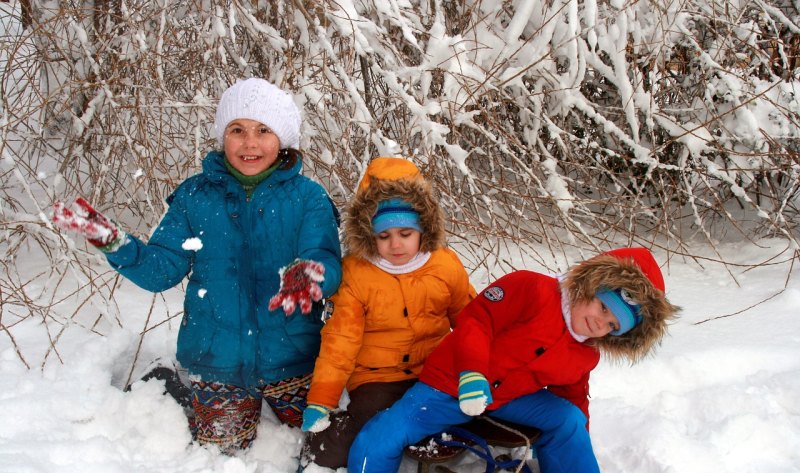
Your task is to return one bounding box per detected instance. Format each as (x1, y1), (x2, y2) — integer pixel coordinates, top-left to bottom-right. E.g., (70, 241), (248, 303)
(343, 158), (445, 259)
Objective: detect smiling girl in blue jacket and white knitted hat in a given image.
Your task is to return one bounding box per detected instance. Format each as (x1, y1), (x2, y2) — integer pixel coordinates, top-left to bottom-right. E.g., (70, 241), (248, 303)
(53, 78), (341, 453)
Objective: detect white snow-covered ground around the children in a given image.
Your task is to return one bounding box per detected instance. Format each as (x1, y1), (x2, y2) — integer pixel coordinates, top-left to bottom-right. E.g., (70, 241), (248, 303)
(0, 240), (800, 473)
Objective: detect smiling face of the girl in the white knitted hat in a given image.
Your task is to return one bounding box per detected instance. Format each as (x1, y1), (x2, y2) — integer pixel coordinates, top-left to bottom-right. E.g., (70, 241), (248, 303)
(223, 118), (280, 176)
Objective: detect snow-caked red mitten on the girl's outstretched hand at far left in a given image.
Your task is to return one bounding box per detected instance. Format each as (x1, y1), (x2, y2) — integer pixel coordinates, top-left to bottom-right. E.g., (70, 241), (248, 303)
(53, 197), (120, 248)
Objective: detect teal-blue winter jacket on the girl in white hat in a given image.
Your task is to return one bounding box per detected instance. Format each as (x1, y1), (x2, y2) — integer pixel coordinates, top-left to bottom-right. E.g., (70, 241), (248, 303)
(106, 151), (342, 388)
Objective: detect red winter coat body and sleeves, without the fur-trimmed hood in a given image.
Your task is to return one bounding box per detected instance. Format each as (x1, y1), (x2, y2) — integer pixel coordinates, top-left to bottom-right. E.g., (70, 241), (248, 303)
(420, 271), (600, 419)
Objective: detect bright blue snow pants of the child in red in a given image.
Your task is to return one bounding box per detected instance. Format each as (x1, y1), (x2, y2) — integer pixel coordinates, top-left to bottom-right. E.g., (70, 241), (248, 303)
(347, 382), (600, 473)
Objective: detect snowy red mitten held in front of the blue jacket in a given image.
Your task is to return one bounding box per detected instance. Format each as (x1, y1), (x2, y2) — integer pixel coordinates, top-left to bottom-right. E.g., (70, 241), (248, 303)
(269, 259), (325, 315)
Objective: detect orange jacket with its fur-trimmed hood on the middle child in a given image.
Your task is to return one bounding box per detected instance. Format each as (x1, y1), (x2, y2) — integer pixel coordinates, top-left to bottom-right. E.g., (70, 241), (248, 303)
(308, 158), (476, 408)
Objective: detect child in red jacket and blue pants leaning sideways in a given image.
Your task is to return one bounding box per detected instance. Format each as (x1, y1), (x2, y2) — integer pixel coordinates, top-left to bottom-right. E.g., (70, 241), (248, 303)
(348, 248), (678, 473)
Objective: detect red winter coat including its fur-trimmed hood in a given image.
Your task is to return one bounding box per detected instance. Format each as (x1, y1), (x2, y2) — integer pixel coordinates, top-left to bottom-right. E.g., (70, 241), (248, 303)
(420, 248), (680, 419)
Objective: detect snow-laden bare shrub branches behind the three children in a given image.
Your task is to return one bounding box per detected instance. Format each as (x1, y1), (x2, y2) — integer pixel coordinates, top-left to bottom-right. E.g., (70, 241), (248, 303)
(0, 0), (800, 365)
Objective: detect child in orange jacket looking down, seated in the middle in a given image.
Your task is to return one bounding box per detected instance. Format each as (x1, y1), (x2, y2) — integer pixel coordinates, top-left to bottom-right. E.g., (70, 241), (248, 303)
(301, 158), (475, 469)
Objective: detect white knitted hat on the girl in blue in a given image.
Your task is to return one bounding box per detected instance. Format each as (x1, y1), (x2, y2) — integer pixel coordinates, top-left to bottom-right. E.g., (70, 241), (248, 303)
(214, 77), (300, 149)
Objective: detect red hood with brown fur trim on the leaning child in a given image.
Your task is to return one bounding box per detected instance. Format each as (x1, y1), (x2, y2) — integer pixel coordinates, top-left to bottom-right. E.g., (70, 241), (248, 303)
(563, 248), (680, 363)
